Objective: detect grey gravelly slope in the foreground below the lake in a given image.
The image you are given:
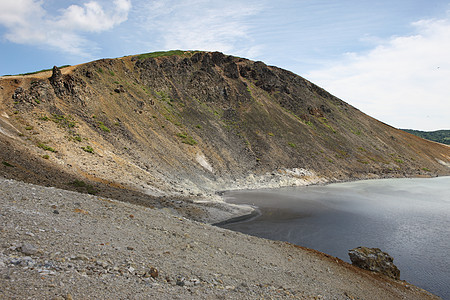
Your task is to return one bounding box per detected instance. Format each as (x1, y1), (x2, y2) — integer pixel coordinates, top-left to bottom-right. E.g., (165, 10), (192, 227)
(0, 177), (437, 299)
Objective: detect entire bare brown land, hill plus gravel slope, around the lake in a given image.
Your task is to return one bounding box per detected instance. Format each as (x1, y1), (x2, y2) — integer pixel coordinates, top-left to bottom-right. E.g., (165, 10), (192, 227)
(0, 51), (450, 299)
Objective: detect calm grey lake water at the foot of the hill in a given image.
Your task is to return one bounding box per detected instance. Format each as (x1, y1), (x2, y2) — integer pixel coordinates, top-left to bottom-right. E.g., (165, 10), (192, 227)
(221, 177), (450, 299)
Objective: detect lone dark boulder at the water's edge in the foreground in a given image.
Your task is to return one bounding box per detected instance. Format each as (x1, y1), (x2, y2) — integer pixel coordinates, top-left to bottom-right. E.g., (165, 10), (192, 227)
(348, 247), (400, 280)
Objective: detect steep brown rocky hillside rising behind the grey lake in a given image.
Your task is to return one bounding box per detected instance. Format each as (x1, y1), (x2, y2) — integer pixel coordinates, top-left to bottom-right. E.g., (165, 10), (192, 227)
(0, 51), (450, 220)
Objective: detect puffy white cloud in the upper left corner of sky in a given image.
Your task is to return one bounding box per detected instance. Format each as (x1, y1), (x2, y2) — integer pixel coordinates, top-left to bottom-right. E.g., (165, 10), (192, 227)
(0, 0), (131, 55)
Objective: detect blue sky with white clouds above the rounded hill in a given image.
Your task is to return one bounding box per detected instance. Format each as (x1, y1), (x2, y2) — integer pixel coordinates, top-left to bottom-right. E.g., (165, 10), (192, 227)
(0, 0), (450, 130)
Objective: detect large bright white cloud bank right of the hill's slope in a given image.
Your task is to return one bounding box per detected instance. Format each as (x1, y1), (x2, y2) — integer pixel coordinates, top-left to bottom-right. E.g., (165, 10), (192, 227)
(306, 15), (450, 130)
